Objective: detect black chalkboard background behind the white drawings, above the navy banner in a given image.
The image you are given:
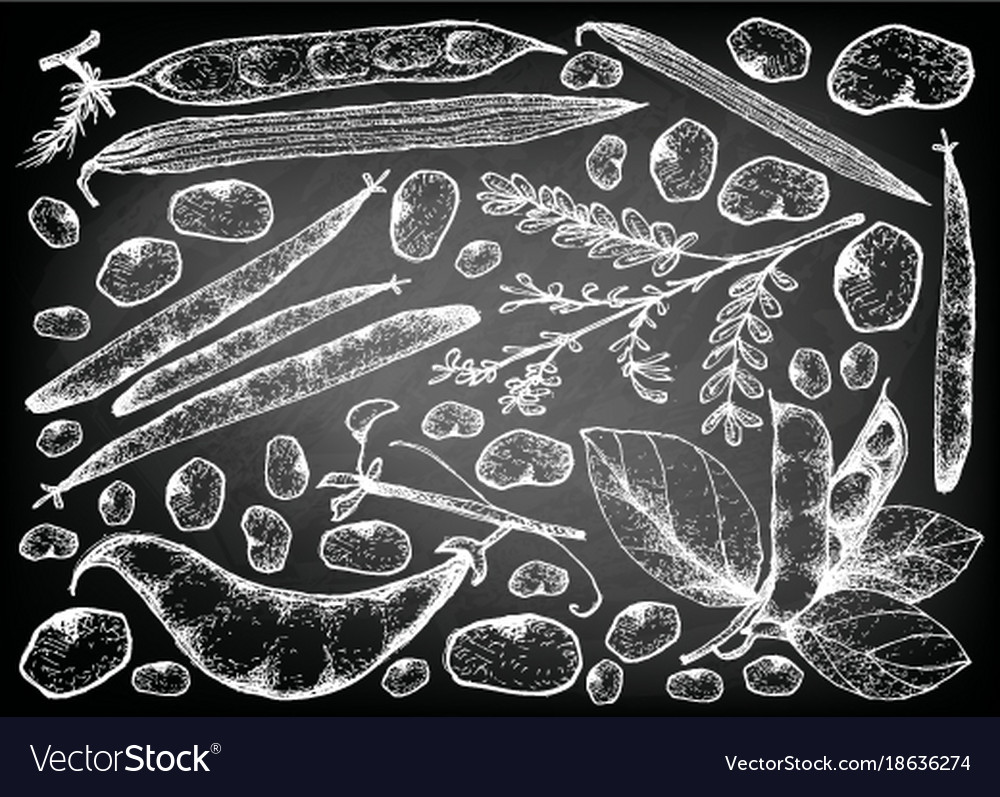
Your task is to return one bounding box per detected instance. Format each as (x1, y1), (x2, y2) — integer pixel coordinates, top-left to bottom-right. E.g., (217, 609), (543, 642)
(2, 3), (998, 716)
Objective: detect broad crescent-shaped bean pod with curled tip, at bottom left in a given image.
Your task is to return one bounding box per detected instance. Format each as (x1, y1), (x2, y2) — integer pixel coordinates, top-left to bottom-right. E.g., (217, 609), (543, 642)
(70, 534), (472, 700)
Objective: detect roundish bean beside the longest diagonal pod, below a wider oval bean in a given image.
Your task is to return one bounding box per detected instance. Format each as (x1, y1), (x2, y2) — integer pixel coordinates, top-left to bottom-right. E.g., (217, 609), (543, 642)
(96, 236), (183, 307)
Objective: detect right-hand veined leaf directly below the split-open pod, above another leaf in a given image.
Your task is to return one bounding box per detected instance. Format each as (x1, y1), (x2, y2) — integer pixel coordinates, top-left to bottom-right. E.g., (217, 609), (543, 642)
(831, 506), (983, 603)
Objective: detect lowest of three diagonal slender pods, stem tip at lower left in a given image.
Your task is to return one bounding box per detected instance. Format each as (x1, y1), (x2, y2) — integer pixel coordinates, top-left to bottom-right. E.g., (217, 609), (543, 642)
(35, 304), (480, 507)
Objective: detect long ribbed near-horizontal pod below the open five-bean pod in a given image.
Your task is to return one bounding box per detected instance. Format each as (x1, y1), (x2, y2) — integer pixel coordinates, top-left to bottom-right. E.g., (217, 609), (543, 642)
(77, 94), (643, 206)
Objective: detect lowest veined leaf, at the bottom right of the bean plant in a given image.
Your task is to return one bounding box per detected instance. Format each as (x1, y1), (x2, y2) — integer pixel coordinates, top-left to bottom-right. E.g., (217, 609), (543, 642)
(787, 590), (969, 700)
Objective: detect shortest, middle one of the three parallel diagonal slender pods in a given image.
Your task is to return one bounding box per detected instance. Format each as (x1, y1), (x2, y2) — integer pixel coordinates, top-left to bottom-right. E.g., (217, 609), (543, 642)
(111, 276), (409, 416)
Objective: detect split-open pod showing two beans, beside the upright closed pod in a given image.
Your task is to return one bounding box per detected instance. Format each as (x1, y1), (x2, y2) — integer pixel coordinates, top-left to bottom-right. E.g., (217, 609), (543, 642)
(830, 380), (909, 558)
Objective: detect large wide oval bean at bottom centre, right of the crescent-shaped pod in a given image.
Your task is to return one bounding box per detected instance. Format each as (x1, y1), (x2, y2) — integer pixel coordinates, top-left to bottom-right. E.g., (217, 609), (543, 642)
(443, 613), (583, 697)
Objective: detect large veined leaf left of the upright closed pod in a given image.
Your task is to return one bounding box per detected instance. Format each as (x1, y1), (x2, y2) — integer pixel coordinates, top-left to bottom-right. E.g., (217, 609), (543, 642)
(580, 427), (763, 606)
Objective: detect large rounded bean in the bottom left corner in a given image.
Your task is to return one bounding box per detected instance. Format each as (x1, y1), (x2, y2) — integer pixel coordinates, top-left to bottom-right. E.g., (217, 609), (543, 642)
(19, 606), (132, 700)
